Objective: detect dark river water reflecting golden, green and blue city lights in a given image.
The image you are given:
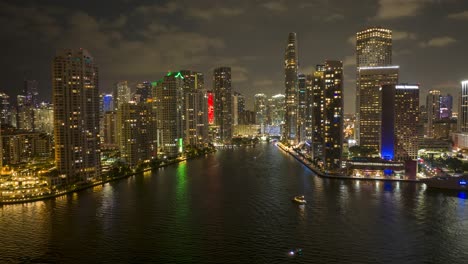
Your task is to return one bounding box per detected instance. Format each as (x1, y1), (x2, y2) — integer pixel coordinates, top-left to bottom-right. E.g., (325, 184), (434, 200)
(0, 143), (468, 263)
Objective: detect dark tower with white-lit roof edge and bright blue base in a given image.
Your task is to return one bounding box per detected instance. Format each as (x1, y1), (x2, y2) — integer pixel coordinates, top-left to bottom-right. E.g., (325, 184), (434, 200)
(380, 84), (419, 161)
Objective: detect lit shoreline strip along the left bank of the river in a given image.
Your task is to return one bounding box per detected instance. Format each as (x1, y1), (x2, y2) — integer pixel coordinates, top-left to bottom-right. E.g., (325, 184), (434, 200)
(0, 150), (216, 204)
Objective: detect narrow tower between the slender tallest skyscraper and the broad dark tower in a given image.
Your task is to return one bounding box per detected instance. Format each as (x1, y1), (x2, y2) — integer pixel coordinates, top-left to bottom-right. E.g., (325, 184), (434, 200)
(297, 73), (309, 142)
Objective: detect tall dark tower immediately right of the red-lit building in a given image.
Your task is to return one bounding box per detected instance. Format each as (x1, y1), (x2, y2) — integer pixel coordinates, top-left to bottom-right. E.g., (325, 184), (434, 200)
(213, 67), (232, 142)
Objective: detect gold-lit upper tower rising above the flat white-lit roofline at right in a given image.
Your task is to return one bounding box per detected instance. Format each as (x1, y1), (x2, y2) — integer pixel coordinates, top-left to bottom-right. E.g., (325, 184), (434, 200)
(356, 27), (392, 67)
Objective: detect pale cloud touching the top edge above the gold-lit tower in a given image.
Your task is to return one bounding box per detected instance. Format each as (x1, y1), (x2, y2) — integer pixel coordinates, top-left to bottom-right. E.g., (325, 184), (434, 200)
(374, 0), (433, 20)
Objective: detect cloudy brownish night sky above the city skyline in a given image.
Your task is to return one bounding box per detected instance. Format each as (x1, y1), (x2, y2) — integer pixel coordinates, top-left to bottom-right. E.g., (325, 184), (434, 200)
(0, 0), (468, 113)
